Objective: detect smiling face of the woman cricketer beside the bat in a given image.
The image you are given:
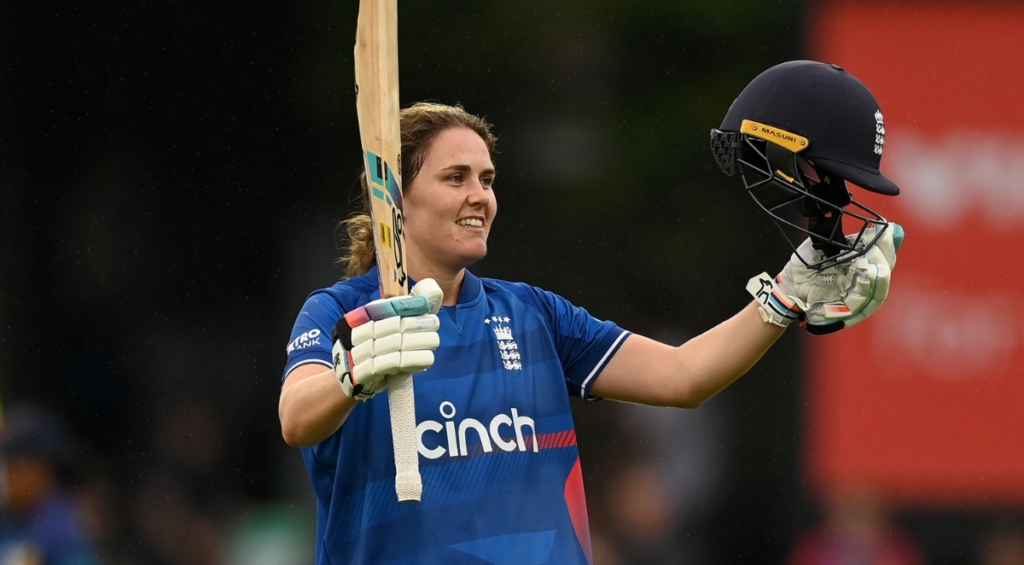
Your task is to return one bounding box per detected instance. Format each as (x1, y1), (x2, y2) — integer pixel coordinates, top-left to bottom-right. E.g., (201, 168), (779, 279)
(402, 127), (498, 279)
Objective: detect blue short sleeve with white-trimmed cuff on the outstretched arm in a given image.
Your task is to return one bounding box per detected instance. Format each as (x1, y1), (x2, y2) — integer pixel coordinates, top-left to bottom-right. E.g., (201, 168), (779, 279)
(531, 288), (630, 400)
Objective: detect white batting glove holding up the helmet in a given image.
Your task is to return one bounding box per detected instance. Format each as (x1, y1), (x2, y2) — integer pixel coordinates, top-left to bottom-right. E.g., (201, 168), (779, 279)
(746, 223), (903, 334)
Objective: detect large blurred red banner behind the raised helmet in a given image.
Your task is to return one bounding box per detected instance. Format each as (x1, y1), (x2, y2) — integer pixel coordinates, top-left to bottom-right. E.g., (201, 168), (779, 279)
(806, 1), (1024, 506)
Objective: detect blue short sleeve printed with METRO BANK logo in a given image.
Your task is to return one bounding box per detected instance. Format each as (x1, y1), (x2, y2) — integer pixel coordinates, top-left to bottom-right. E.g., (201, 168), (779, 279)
(281, 294), (341, 382)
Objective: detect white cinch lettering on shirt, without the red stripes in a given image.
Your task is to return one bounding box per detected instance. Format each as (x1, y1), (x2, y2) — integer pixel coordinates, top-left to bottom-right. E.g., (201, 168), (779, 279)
(416, 400), (540, 460)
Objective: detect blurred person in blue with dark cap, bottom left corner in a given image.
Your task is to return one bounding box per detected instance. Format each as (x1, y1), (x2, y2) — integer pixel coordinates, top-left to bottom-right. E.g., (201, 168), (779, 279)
(0, 405), (97, 565)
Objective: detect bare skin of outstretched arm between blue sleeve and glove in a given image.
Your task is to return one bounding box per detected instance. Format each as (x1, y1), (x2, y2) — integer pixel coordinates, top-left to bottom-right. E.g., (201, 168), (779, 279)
(591, 302), (785, 408)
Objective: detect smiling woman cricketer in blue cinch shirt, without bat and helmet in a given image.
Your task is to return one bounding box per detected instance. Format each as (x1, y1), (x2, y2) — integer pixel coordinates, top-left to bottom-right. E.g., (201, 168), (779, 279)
(280, 61), (895, 564)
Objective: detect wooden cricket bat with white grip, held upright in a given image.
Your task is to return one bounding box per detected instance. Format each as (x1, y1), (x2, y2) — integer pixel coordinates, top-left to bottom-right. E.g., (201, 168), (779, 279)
(355, 0), (423, 503)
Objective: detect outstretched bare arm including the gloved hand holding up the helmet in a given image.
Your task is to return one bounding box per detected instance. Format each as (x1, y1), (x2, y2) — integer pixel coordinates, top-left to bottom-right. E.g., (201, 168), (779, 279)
(591, 224), (903, 408)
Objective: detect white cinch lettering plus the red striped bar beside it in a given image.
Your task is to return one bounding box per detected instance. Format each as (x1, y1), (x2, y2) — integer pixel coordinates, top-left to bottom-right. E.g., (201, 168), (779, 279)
(416, 400), (575, 460)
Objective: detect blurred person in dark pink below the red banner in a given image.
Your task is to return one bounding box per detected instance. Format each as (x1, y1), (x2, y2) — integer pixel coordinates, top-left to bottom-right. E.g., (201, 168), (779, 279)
(788, 486), (925, 565)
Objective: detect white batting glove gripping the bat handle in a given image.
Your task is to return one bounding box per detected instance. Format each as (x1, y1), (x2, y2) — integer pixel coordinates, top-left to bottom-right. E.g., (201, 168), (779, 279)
(333, 278), (444, 400)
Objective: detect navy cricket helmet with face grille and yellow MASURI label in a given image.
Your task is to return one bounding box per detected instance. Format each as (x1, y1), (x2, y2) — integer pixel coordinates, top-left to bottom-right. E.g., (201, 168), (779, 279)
(711, 60), (899, 269)
